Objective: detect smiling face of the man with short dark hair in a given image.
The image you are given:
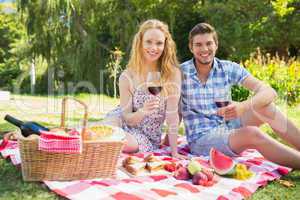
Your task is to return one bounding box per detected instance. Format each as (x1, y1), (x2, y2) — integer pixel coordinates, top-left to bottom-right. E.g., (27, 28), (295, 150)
(189, 33), (218, 65)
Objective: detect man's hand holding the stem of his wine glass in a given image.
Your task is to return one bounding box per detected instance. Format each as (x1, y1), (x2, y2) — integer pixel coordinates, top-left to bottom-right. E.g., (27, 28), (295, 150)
(217, 102), (246, 120)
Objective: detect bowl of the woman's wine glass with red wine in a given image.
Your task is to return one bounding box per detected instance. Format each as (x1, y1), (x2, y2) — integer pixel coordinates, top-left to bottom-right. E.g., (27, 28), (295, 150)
(147, 72), (162, 96)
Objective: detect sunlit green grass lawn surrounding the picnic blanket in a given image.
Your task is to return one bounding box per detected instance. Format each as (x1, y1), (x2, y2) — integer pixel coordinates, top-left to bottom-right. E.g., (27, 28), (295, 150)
(0, 94), (300, 200)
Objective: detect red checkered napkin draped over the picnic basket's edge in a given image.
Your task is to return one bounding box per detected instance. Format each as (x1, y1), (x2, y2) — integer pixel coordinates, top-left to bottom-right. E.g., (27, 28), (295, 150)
(39, 130), (82, 154)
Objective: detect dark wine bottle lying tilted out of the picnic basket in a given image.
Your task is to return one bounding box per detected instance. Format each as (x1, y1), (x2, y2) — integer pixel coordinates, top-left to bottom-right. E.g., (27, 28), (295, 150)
(4, 115), (49, 137)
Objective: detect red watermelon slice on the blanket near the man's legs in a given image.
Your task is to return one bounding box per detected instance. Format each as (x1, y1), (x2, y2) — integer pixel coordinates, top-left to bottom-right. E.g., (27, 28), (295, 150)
(209, 148), (235, 175)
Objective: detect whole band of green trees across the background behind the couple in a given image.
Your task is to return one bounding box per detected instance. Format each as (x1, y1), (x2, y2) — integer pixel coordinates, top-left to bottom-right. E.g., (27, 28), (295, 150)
(0, 0), (300, 98)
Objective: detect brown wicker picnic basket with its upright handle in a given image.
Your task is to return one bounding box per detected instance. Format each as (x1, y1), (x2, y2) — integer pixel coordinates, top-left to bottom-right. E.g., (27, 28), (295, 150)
(18, 97), (124, 181)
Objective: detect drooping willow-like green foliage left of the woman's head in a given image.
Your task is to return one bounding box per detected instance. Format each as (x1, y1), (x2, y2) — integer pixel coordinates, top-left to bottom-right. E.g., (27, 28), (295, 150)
(14, 0), (136, 92)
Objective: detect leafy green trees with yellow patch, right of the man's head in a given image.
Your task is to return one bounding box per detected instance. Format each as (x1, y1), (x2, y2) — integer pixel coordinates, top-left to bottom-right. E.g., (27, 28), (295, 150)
(197, 0), (300, 61)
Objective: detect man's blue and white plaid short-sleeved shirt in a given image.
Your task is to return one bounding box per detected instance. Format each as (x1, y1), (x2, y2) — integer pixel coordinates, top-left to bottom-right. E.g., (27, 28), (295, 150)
(181, 58), (250, 143)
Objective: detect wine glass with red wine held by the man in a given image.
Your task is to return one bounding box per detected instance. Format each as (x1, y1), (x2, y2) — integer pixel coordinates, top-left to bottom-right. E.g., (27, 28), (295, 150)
(214, 87), (232, 124)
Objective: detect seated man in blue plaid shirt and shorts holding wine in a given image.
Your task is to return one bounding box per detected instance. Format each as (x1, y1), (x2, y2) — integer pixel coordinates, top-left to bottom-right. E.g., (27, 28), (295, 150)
(181, 23), (300, 169)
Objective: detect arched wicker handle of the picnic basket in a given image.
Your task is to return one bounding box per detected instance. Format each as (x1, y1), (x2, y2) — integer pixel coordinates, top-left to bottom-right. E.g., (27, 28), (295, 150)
(60, 97), (88, 140)
